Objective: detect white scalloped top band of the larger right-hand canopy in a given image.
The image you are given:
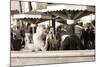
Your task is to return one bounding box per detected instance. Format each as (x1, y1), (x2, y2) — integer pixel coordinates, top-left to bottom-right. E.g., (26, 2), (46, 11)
(42, 4), (95, 12)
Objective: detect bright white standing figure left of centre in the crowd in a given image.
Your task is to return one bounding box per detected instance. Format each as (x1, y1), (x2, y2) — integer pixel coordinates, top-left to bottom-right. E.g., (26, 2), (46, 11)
(33, 25), (46, 51)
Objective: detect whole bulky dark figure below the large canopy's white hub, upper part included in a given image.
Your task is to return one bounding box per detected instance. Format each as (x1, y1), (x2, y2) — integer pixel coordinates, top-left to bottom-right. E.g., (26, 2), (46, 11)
(60, 24), (81, 50)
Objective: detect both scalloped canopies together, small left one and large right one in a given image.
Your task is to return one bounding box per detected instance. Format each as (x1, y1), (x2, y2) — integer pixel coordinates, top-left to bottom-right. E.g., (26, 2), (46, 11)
(13, 4), (95, 24)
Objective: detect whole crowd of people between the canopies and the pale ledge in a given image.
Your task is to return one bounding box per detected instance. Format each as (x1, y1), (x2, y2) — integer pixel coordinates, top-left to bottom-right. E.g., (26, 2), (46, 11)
(11, 22), (95, 51)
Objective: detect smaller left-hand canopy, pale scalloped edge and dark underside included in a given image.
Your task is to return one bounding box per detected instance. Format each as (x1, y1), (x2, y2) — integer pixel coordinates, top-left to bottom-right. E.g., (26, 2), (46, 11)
(13, 11), (51, 23)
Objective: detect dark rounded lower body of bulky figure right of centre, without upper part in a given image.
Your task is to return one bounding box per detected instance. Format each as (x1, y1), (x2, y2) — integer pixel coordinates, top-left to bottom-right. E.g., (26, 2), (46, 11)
(61, 35), (81, 50)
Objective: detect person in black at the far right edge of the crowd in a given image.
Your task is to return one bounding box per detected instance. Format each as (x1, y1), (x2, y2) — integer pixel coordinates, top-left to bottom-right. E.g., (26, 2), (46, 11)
(83, 23), (95, 49)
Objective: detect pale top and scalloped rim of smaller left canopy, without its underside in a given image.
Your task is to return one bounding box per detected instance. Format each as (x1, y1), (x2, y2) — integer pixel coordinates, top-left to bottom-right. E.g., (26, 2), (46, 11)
(13, 11), (51, 19)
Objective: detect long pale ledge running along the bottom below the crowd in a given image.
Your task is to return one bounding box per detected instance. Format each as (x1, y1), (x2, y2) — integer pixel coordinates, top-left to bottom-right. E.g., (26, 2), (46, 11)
(11, 50), (95, 66)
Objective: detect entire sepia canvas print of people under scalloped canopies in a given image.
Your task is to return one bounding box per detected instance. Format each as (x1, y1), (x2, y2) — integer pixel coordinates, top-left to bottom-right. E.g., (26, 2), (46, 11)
(10, 0), (96, 66)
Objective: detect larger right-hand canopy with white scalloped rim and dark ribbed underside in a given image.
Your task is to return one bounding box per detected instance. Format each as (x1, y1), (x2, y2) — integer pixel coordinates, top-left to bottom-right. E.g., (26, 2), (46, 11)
(39, 4), (95, 21)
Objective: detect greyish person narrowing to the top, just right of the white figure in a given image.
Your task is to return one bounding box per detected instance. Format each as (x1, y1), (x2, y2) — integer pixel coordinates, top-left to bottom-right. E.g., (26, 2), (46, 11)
(46, 27), (59, 50)
